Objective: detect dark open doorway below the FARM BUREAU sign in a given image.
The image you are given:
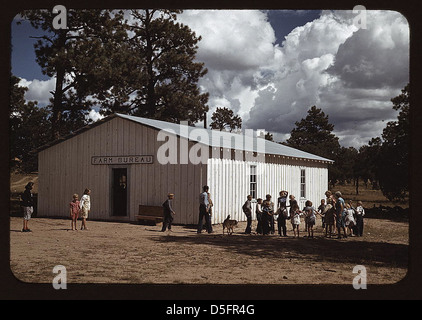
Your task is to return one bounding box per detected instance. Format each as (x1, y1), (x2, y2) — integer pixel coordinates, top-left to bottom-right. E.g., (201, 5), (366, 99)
(111, 168), (128, 217)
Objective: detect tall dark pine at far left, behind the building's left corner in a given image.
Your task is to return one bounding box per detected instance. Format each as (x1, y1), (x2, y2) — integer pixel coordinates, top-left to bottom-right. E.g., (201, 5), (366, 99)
(22, 10), (125, 139)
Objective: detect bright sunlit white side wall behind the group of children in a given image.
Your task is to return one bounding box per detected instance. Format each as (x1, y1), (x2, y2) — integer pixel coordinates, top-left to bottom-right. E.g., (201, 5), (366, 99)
(208, 158), (328, 223)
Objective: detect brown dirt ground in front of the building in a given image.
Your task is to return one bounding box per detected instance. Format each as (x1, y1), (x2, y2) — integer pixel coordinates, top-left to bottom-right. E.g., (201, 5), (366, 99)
(10, 217), (409, 285)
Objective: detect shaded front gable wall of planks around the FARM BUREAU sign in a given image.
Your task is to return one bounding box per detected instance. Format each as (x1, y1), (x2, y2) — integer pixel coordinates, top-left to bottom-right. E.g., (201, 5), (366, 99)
(38, 117), (207, 224)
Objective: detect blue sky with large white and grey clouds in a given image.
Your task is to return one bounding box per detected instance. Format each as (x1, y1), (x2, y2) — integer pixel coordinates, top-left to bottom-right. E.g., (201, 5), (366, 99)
(11, 10), (410, 147)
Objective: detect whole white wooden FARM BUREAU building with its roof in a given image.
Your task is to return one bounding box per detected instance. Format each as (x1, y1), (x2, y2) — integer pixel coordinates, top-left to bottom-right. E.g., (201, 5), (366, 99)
(38, 114), (332, 224)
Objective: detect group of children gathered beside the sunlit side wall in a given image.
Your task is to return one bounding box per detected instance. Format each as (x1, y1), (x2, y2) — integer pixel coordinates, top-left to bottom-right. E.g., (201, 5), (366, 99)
(252, 191), (365, 238)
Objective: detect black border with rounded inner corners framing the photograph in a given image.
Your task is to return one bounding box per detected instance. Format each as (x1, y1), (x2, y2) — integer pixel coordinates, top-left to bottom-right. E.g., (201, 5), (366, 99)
(0, 0), (422, 302)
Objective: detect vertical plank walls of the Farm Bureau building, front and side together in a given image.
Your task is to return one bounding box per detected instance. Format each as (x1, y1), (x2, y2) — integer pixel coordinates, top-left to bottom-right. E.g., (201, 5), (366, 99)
(38, 117), (328, 224)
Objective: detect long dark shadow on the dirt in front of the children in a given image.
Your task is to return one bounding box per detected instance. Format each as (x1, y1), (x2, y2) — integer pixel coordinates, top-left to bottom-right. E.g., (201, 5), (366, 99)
(152, 234), (408, 268)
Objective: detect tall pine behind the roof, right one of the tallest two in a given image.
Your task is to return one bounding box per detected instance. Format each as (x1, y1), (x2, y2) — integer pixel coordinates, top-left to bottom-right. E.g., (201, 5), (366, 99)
(116, 9), (208, 123)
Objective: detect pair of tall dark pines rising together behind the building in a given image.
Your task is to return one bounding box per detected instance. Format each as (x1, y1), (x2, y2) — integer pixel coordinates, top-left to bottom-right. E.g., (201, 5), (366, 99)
(22, 9), (208, 135)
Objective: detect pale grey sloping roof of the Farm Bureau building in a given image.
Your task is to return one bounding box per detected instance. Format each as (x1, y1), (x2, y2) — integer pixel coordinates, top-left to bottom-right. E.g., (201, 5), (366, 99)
(115, 113), (334, 162)
